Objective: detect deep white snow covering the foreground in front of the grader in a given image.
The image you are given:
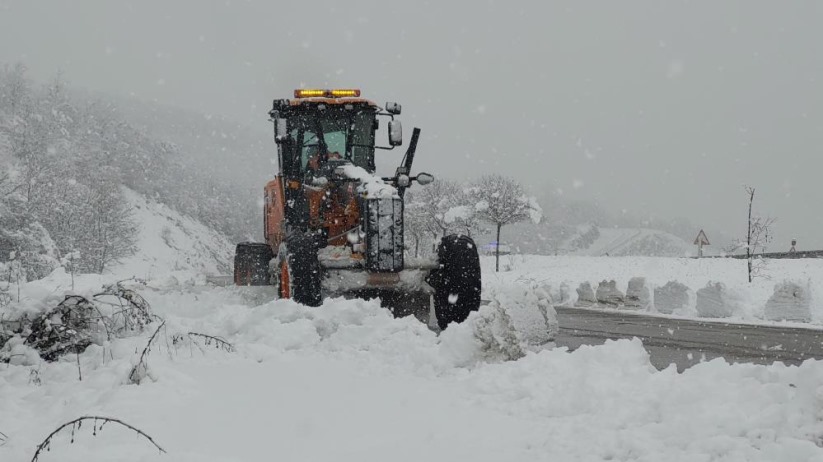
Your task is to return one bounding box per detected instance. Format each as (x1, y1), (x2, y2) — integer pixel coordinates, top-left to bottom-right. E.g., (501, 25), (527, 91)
(0, 279), (823, 462)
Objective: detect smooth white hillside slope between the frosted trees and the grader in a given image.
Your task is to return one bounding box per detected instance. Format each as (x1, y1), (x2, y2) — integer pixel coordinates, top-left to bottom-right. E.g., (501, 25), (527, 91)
(112, 190), (234, 279)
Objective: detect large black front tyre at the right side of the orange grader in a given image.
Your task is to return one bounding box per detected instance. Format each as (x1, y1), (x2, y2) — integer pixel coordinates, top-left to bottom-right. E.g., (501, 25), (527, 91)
(429, 235), (481, 329)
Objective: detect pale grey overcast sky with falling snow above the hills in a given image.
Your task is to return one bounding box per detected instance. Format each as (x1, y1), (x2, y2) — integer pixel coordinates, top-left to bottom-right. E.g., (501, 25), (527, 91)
(0, 0), (823, 249)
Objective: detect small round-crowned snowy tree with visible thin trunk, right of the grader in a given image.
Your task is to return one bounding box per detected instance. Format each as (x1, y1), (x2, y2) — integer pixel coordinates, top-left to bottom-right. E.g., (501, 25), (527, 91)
(469, 174), (542, 271)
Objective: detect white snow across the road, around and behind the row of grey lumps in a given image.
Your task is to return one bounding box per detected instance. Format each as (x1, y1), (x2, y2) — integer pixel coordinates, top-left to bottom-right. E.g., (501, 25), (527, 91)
(481, 255), (823, 324)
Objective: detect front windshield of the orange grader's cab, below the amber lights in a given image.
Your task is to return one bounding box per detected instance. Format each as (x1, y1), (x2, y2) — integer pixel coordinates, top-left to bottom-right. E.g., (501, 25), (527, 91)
(291, 110), (374, 172)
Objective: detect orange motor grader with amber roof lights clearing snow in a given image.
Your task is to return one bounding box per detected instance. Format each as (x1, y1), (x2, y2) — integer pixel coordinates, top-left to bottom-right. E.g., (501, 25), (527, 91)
(234, 89), (481, 329)
